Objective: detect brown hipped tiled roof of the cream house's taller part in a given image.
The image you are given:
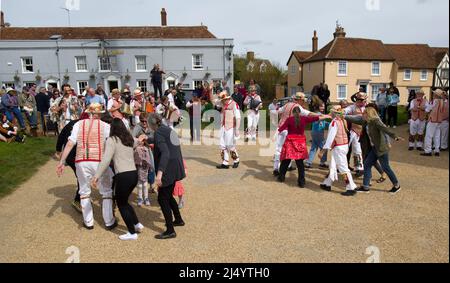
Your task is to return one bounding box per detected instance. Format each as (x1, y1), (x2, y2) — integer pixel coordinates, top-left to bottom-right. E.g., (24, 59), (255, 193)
(304, 37), (394, 62)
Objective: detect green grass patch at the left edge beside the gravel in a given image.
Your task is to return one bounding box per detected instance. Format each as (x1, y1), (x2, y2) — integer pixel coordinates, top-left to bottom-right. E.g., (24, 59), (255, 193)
(0, 137), (56, 198)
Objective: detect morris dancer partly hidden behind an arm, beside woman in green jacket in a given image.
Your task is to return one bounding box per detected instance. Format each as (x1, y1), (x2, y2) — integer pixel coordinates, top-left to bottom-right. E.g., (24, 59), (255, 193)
(344, 92), (367, 177)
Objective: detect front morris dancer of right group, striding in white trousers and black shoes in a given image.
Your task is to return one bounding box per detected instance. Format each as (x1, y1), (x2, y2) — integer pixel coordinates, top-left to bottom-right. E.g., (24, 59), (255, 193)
(319, 105), (356, 196)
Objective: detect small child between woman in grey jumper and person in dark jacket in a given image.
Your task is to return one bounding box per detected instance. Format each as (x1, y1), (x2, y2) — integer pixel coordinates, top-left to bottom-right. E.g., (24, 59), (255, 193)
(134, 142), (153, 207)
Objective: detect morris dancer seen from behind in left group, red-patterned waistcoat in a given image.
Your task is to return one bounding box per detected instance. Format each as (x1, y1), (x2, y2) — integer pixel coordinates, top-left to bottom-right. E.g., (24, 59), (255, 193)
(56, 103), (117, 230)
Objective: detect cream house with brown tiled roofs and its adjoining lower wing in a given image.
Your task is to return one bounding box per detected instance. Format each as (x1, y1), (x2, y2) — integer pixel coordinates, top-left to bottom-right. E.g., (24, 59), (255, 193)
(288, 25), (446, 104)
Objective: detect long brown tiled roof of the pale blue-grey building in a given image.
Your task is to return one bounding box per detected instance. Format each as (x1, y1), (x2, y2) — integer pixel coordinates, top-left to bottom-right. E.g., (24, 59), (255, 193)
(0, 26), (216, 40)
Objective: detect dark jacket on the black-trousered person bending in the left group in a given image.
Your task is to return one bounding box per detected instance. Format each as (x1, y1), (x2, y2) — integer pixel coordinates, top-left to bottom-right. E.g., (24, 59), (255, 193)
(154, 126), (186, 187)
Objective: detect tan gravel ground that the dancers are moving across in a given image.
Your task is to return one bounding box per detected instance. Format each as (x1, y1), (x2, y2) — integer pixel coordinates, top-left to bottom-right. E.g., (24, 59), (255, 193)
(0, 127), (449, 262)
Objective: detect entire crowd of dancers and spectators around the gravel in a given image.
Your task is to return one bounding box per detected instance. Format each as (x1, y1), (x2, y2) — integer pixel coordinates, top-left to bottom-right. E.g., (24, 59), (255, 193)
(0, 77), (448, 240)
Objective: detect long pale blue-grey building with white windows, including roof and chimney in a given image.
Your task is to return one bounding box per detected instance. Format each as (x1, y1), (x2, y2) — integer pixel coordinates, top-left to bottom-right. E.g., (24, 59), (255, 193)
(0, 11), (234, 93)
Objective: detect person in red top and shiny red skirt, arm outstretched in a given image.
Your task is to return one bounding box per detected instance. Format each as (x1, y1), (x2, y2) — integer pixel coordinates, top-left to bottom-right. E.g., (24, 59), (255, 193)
(278, 107), (331, 188)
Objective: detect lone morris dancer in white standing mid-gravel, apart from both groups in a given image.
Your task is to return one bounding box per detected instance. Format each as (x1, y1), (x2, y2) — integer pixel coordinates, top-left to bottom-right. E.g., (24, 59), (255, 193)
(217, 91), (241, 169)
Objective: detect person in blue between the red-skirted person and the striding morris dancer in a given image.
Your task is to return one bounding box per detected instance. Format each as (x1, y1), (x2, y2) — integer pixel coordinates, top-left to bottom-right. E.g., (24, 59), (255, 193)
(305, 103), (330, 168)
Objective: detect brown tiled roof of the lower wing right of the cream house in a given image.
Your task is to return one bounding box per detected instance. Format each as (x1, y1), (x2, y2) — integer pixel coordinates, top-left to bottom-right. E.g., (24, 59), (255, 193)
(386, 44), (437, 69)
